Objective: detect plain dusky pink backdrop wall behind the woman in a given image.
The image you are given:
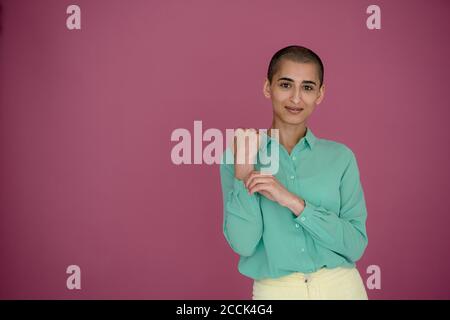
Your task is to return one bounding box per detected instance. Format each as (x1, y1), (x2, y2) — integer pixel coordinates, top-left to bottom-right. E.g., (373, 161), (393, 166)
(0, 0), (450, 299)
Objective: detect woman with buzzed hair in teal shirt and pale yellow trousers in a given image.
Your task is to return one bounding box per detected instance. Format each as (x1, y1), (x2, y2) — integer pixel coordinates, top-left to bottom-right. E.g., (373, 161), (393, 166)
(220, 46), (367, 300)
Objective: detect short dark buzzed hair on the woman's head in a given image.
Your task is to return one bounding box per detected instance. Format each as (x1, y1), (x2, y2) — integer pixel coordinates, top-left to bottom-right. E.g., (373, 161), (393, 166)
(267, 45), (324, 87)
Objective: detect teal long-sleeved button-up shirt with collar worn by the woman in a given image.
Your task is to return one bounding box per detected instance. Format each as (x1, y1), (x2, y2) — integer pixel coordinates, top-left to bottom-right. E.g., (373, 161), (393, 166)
(220, 127), (367, 279)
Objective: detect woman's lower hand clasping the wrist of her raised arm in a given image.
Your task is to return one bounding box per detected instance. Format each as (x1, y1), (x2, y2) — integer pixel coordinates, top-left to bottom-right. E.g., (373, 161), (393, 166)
(244, 171), (305, 216)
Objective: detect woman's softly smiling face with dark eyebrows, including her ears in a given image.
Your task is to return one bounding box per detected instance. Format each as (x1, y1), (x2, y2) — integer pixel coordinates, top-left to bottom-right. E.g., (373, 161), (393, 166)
(264, 59), (325, 125)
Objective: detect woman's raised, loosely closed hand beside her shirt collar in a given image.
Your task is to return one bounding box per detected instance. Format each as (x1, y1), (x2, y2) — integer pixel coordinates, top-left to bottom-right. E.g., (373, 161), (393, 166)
(231, 128), (260, 180)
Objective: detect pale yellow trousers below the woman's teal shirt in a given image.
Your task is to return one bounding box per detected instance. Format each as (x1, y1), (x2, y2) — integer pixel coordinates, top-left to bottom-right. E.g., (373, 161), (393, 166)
(253, 267), (368, 300)
